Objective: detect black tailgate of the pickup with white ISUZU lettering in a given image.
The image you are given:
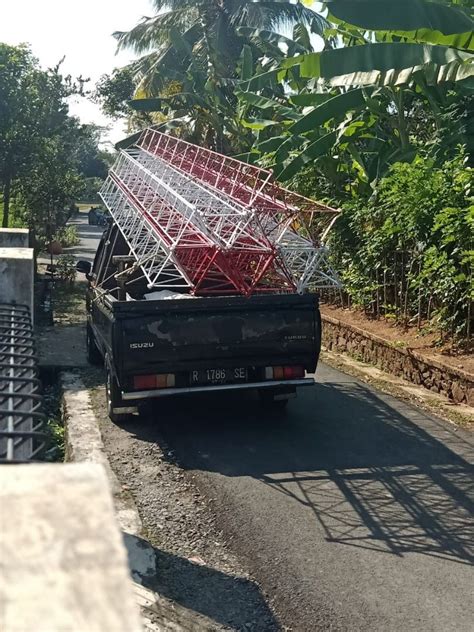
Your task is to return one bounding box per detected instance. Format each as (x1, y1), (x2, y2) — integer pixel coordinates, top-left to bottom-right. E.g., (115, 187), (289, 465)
(113, 294), (321, 375)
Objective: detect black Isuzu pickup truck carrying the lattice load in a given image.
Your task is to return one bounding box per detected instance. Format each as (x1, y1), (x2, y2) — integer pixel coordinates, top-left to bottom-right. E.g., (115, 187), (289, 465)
(77, 226), (321, 422)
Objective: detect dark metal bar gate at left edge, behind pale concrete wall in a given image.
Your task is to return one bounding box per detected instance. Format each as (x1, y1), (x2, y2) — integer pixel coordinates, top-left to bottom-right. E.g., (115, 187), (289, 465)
(0, 304), (45, 463)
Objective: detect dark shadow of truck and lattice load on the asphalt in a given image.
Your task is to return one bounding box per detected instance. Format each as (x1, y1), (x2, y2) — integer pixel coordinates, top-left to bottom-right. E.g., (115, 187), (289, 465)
(131, 379), (474, 564)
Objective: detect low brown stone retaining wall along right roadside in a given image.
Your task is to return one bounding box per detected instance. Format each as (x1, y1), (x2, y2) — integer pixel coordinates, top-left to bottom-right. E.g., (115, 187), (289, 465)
(322, 315), (474, 406)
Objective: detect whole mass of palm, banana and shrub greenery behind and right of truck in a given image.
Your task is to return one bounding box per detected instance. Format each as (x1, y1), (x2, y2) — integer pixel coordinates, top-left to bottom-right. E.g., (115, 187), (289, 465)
(101, 0), (474, 337)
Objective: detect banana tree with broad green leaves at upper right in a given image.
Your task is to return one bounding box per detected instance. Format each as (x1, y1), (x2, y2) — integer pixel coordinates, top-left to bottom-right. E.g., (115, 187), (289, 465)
(240, 0), (474, 193)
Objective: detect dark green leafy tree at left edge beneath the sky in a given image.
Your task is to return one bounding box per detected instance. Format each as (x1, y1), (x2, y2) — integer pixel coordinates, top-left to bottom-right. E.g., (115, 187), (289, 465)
(0, 43), (110, 246)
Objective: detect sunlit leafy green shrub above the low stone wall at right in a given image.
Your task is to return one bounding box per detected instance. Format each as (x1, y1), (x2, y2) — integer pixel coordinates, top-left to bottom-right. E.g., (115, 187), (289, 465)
(331, 151), (474, 337)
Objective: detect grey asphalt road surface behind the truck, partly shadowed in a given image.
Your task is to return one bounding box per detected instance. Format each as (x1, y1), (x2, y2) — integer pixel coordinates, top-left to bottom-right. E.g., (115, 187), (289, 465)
(136, 365), (474, 632)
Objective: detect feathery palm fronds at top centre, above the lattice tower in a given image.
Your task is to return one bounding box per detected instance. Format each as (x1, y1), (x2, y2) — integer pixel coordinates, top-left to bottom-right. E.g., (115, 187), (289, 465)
(105, 0), (326, 151)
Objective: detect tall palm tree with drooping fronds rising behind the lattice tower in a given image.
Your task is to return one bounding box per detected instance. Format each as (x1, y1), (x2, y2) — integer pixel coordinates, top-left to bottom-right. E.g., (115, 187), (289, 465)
(114, 0), (326, 149)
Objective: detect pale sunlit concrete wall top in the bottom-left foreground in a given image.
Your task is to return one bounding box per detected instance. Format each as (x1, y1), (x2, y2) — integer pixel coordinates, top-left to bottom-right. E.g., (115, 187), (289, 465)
(0, 464), (143, 632)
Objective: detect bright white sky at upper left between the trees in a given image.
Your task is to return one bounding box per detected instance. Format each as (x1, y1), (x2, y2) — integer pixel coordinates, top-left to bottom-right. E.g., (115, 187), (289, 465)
(0, 0), (154, 142)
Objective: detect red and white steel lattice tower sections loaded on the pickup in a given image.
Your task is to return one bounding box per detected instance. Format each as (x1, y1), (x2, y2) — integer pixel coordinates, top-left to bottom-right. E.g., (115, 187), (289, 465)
(101, 129), (337, 295)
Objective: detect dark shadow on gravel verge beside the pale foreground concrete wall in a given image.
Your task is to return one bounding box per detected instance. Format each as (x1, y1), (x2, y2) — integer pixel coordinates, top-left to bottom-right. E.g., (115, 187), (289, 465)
(124, 534), (280, 632)
